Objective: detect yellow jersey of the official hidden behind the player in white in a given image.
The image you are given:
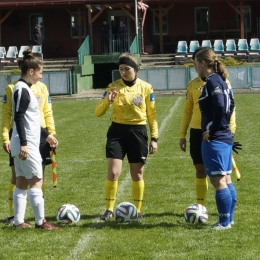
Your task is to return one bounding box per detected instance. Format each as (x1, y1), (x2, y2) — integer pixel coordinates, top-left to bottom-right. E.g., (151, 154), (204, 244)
(2, 81), (56, 143)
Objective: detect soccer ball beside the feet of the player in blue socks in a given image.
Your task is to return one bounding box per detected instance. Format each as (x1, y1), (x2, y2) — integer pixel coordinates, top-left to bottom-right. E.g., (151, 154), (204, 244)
(184, 203), (208, 223)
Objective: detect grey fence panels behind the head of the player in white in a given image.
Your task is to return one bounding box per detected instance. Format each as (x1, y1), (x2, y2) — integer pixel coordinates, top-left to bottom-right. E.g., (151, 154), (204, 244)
(0, 71), (74, 96)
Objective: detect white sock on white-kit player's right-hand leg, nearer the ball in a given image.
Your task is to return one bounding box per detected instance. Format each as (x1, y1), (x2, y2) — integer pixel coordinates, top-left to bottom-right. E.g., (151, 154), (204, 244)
(28, 188), (44, 225)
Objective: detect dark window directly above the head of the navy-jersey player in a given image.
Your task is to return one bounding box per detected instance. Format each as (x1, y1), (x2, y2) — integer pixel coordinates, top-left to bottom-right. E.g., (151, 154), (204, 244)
(195, 7), (209, 34)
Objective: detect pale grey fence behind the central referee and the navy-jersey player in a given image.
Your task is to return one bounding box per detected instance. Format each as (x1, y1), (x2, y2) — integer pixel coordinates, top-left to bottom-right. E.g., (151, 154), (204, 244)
(112, 66), (260, 90)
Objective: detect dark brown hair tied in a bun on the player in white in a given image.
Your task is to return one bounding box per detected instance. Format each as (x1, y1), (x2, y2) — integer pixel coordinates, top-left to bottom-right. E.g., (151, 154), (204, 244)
(18, 48), (43, 76)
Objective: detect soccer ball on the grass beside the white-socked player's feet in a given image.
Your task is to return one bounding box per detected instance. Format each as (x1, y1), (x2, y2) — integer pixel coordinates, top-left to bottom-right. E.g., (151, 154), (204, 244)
(56, 204), (80, 224)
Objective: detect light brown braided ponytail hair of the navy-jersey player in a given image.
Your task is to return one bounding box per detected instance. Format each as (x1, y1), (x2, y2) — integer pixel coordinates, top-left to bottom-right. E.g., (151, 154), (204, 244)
(195, 48), (228, 80)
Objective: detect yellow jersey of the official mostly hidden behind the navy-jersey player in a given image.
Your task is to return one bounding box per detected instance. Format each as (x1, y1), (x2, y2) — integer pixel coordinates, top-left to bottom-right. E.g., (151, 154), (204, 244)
(179, 77), (236, 138)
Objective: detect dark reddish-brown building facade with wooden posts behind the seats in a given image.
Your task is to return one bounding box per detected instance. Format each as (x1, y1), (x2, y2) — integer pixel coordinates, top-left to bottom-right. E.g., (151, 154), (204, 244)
(0, 0), (260, 58)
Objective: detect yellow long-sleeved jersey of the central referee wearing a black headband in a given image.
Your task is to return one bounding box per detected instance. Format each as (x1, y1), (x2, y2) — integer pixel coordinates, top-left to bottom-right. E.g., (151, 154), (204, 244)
(95, 78), (158, 138)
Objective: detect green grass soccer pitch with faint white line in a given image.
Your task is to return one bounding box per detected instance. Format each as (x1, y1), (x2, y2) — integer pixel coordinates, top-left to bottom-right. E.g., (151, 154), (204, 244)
(0, 94), (260, 260)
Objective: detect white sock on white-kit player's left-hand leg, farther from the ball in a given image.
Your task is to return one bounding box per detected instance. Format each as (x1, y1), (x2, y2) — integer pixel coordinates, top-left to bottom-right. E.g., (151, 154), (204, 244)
(13, 187), (27, 225)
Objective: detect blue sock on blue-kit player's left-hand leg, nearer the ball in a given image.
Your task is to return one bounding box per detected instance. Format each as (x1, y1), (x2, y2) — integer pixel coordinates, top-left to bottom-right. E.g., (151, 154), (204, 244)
(216, 188), (232, 227)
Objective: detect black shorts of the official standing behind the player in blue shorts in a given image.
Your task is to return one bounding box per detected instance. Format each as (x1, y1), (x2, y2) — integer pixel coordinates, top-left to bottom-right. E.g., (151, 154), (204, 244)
(190, 128), (203, 165)
